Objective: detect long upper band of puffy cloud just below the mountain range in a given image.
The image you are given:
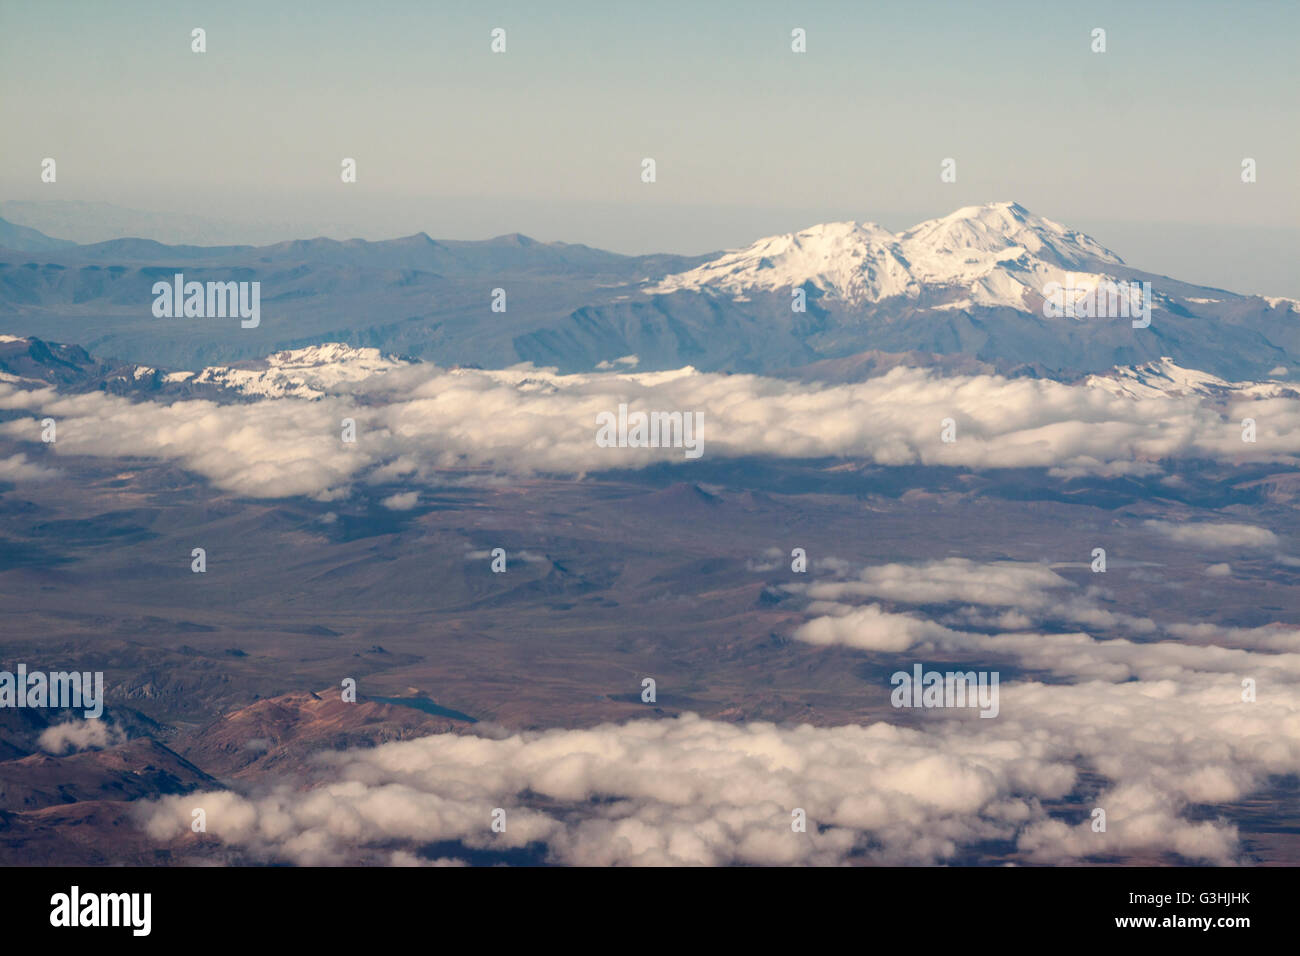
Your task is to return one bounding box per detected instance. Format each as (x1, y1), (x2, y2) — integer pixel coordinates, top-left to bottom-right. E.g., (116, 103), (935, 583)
(0, 364), (1300, 498)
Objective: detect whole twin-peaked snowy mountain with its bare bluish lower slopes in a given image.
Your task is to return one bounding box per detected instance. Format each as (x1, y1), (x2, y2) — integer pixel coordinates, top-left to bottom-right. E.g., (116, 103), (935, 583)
(515, 202), (1300, 380)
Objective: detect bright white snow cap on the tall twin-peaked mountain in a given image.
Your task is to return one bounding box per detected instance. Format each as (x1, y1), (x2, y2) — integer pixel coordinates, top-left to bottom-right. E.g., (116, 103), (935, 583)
(647, 202), (1123, 311)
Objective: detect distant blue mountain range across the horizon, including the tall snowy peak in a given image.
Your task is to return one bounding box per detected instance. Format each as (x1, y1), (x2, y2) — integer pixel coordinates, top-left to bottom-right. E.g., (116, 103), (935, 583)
(0, 202), (1300, 381)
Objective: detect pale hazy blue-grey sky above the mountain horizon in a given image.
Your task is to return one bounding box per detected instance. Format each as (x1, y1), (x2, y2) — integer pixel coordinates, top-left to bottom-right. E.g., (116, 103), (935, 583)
(0, 0), (1300, 295)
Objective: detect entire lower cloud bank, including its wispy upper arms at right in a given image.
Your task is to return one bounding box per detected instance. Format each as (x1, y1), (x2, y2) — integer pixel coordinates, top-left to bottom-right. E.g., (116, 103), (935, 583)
(139, 559), (1300, 865)
